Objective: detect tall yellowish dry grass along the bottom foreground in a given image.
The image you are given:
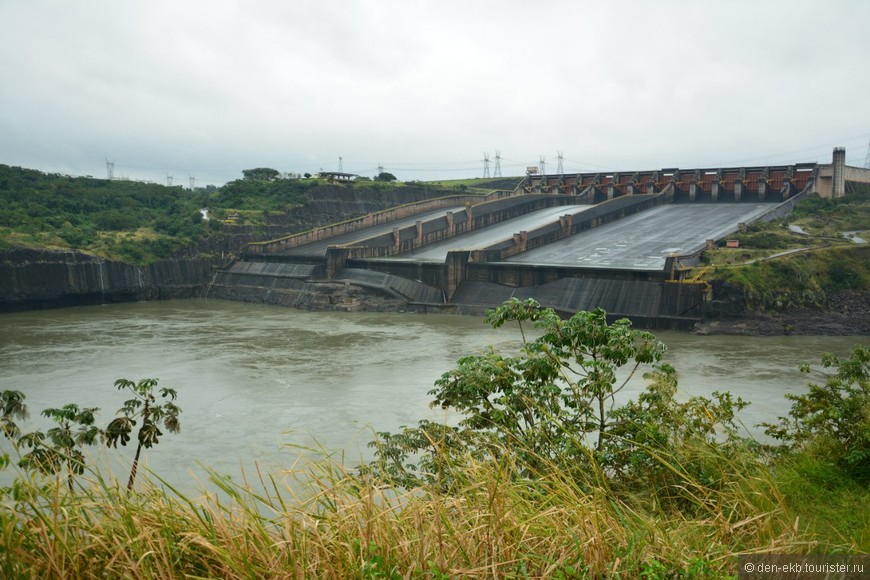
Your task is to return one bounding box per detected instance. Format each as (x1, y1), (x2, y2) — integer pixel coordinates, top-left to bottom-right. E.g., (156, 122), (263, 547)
(0, 438), (824, 578)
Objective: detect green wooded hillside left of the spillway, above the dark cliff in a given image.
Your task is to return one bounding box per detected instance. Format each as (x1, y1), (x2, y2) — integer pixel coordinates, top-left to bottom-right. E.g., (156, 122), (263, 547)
(0, 164), (510, 264)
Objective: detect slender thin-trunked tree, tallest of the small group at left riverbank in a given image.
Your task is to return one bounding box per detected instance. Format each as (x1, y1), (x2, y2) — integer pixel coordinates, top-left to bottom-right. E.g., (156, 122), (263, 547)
(106, 379), (181, 489)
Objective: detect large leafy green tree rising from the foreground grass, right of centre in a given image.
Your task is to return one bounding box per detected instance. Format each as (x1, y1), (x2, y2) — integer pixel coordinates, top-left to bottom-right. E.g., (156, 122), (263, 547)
(372, 299), (665, 481)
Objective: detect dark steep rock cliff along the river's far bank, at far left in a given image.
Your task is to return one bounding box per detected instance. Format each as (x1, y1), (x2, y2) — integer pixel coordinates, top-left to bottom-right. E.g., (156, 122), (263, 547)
(0, 250), (216, 312)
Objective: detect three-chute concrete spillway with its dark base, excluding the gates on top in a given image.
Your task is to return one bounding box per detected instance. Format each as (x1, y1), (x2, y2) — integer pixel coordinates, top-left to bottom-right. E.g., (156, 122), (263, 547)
(210, 192), (792, 327)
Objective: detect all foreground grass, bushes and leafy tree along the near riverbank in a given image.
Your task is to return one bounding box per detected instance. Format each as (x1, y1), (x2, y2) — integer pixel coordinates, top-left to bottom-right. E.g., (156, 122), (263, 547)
(0, 301), (870, 578)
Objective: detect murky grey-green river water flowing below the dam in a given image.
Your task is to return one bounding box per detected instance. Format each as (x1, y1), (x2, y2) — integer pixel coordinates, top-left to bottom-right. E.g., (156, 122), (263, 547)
(0, 300), (868, 489)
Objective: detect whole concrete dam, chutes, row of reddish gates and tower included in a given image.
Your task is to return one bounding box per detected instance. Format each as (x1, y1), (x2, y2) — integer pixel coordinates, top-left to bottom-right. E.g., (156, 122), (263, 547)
(209, 150), (870, 328)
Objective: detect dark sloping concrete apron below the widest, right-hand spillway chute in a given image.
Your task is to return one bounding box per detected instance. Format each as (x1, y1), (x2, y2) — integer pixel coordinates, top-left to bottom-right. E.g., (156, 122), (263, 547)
(451, 278), (703, 327)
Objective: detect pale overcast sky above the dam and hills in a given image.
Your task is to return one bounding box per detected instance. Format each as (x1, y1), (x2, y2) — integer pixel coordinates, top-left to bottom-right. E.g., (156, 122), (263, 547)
(0, 0), (870, 185)
